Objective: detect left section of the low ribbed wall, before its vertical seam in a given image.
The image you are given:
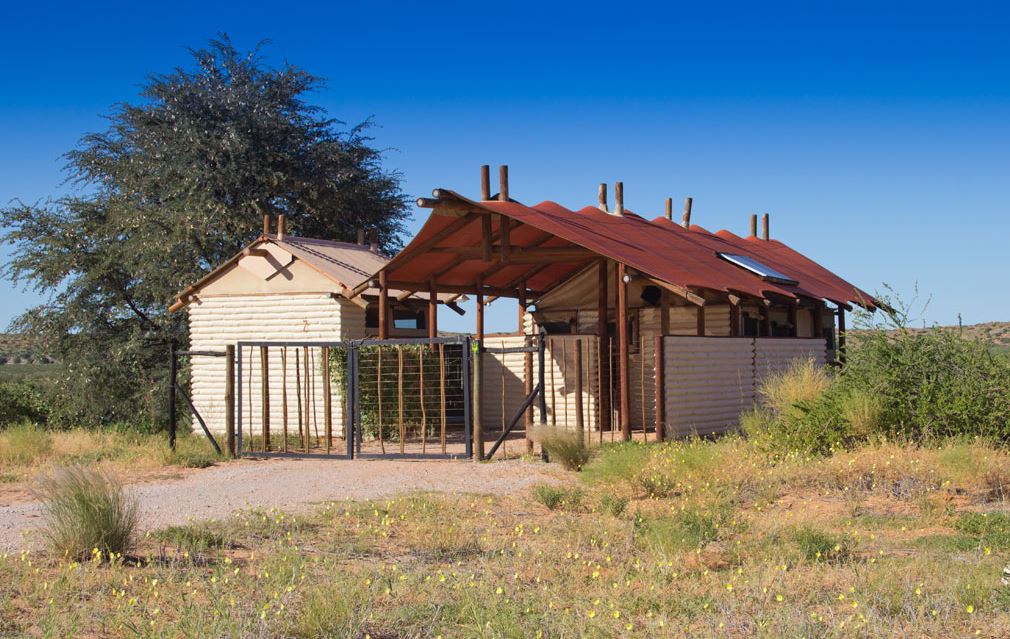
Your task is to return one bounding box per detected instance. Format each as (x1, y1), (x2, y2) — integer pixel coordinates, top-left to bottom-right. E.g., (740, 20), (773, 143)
(664, 336), (754, 436)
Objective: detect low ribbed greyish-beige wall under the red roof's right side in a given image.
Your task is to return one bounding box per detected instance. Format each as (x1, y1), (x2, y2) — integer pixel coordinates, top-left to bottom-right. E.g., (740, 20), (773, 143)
(664, 336), (826, 437)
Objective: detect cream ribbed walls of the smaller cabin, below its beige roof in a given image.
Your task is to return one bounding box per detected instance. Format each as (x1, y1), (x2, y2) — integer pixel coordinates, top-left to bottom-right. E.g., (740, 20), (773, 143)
(189, 294), (351, 436)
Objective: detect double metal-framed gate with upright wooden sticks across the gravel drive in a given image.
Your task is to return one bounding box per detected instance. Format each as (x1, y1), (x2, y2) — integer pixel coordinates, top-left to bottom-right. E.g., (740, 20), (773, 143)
(233, 336), (473, 458)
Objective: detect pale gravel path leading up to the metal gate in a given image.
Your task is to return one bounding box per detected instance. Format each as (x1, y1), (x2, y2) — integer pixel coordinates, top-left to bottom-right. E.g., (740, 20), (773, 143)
(0, 459), (558, 550)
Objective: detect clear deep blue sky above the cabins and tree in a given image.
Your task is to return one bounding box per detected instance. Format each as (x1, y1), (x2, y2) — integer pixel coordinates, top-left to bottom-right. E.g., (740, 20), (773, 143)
(0, 0), (1010, 330)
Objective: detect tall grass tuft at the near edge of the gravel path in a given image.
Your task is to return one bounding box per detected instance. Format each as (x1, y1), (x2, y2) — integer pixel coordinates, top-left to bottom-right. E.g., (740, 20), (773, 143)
(36, 466), (138, 559)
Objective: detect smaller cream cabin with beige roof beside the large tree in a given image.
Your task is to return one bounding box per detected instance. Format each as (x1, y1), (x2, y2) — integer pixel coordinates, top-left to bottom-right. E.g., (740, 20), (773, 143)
(170, 215), (462, 436)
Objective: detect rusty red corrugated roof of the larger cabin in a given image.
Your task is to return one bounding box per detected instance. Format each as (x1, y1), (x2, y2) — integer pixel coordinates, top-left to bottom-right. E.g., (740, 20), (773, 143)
(384, 189), (870, 304)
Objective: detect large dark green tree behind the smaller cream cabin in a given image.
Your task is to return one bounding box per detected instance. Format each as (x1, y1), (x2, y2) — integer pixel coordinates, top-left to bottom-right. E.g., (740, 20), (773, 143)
(0, 36), (407, 423)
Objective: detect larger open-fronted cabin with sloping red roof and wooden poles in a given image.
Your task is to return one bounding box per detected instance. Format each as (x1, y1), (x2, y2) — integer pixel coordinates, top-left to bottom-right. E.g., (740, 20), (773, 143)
(365, 167), (877, 450)
